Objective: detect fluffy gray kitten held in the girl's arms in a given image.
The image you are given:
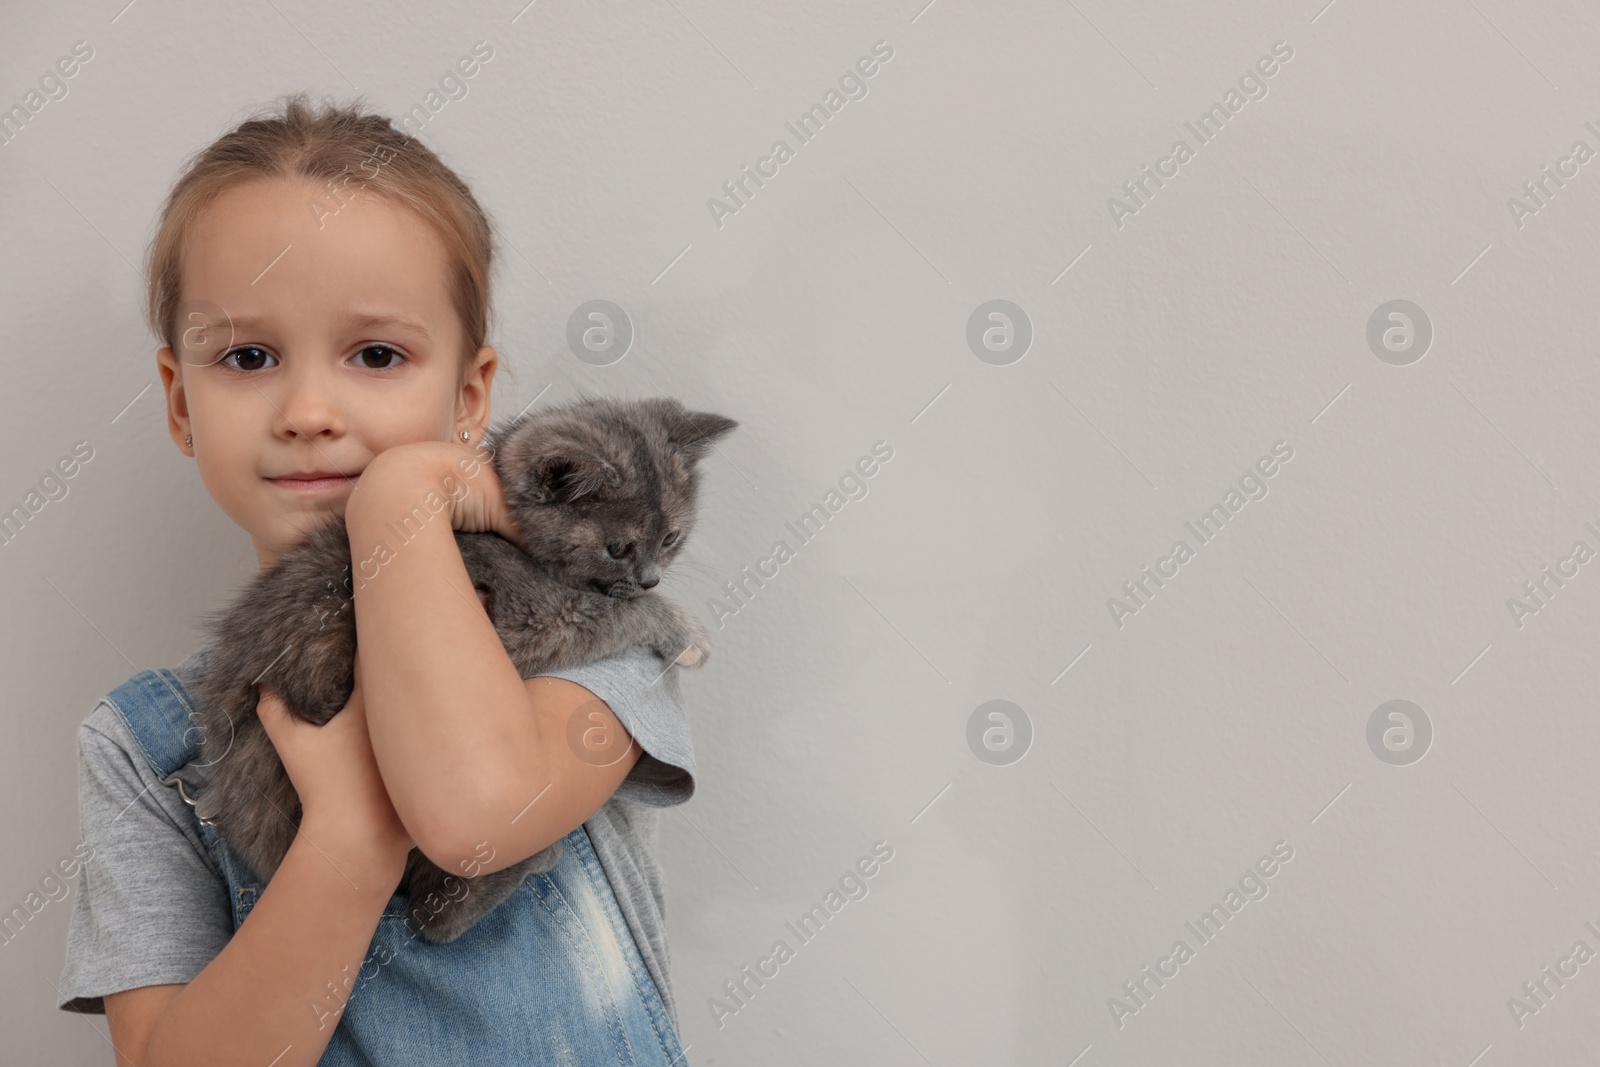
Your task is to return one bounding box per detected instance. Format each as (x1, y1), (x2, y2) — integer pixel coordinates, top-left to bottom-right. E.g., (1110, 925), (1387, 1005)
(195, 397), (738, 944)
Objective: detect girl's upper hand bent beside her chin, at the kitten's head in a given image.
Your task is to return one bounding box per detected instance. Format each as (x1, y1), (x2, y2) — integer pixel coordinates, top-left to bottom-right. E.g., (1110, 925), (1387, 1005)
(349, 442), (525, 547)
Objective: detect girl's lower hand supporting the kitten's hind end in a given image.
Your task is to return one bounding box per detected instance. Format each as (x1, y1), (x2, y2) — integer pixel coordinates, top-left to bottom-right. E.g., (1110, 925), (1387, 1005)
(256, 653), (416, 885)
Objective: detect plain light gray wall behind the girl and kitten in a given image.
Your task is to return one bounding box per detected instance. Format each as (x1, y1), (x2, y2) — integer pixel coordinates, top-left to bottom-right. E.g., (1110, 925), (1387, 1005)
(0, 0), (1600, 1067)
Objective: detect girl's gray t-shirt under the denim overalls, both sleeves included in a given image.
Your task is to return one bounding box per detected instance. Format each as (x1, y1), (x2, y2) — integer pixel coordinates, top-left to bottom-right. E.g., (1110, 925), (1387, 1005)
(58, 646), (694, 1029)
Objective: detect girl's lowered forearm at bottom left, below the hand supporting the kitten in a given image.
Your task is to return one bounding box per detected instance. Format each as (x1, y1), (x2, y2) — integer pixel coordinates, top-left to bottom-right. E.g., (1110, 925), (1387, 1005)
(141, 822), (405, 1067)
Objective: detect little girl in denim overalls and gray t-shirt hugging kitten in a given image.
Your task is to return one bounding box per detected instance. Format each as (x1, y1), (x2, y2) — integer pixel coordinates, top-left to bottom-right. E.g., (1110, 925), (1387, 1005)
(59, 94), (694, 1067)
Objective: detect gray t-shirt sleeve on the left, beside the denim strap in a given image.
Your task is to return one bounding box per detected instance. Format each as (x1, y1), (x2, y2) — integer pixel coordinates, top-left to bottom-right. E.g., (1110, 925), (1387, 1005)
(58, 704), (234, 1014)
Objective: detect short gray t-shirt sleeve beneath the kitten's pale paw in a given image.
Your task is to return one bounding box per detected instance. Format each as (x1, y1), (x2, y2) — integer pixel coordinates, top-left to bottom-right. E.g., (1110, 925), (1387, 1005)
(538, 645), (694, 808)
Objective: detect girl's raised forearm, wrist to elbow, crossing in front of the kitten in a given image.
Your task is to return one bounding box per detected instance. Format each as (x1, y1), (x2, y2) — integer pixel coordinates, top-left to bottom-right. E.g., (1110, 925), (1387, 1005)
(346, 459), (542, 869)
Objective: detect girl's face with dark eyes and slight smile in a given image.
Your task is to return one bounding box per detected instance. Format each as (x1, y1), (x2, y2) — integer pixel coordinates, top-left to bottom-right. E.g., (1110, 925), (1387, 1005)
(157, 179), (496, 568)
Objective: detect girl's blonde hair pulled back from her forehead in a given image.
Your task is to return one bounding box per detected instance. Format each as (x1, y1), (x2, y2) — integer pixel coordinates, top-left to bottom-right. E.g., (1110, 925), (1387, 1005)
(144, 93), (498, 384)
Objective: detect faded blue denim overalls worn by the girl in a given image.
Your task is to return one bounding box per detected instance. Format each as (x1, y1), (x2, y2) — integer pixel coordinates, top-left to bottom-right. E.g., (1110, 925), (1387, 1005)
(106, 669), (686, 1067)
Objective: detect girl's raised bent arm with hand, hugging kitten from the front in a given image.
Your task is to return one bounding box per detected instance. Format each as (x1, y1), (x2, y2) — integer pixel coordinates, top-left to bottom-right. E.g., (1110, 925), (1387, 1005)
(344, 443), (640, 875)
